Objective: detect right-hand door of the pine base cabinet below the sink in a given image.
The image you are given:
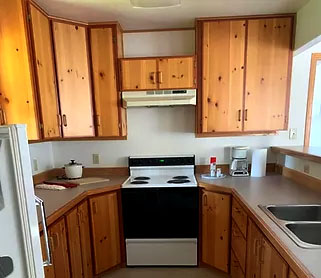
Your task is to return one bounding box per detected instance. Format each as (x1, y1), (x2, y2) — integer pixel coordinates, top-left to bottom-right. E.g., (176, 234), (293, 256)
(260, 237), (288, 278)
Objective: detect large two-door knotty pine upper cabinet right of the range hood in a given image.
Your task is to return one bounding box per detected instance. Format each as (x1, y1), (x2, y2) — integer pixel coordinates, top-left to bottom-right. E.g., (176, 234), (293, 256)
(196, 15), (294, 136)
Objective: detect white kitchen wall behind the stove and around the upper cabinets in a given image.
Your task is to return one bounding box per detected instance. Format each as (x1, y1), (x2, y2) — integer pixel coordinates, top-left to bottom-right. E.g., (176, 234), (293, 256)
(29, 31), (307, 170)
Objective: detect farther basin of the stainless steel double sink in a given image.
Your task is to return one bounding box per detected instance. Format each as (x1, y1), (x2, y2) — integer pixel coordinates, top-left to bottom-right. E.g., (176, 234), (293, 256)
(267, 205), (321, 221)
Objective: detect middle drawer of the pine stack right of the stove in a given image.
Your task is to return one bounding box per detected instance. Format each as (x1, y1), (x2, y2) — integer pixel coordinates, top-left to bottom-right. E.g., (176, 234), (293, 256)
(231, 220), (246, 272)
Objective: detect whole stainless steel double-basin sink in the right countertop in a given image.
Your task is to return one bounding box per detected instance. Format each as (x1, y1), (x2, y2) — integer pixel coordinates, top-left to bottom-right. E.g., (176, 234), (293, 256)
(259, 205), (321, 249)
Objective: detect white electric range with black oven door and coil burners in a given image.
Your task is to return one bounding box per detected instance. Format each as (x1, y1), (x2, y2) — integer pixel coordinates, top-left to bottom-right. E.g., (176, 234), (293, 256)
(122, 155), (199, 266)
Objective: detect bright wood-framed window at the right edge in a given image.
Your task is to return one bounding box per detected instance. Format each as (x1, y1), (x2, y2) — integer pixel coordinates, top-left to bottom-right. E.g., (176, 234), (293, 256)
(304, 53), (321, 147)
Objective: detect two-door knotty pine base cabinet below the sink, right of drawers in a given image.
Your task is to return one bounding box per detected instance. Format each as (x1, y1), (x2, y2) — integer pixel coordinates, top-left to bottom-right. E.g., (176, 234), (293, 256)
(246, 220), (289, 278)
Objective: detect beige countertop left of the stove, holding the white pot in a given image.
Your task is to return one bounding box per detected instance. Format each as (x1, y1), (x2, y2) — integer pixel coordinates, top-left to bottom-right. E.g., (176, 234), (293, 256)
(35, 176), (128, 225)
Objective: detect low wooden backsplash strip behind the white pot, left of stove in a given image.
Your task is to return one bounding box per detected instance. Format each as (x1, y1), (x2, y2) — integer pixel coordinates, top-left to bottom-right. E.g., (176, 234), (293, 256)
(33, 167), (129, 184)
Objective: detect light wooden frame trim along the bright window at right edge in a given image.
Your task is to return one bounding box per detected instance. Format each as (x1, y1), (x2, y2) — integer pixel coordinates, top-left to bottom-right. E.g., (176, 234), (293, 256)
(304, 53), (321, 146)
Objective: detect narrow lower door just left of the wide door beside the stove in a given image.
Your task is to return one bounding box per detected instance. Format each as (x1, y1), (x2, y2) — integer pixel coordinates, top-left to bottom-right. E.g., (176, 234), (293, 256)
(78, 201), (94, 278)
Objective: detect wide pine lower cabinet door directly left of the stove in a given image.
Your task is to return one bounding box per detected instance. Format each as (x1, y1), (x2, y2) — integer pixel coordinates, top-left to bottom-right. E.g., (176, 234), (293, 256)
(90, 193), (120, 274)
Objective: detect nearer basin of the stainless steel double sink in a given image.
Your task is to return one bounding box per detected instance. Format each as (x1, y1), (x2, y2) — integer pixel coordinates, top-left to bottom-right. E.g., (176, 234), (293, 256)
(285, 223), (321, 246)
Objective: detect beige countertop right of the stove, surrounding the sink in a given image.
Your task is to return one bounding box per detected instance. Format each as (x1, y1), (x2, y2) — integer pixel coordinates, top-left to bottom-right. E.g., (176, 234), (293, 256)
(197, 175), (321, 278)
